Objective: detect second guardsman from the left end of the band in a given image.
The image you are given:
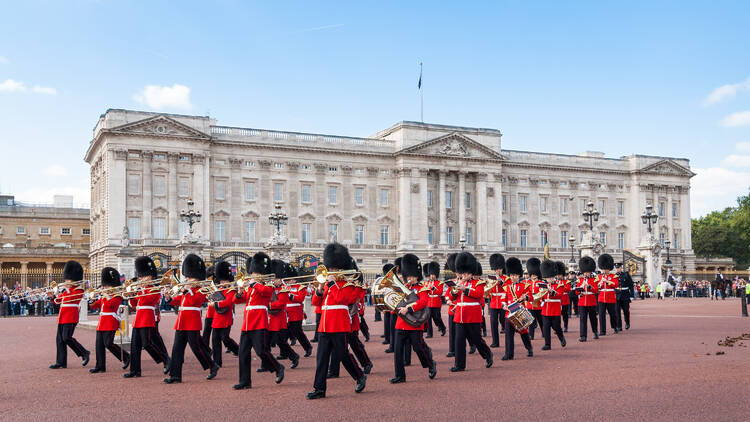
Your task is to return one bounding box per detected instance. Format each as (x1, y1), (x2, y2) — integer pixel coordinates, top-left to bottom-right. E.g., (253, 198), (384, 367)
(89, 267), (130, 374)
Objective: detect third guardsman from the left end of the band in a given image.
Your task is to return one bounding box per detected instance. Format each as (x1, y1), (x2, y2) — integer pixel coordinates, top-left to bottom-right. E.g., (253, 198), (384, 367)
(122, 256), (170, 378)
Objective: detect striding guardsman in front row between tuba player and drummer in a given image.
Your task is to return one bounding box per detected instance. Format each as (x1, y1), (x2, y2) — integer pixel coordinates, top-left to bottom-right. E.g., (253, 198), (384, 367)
(451, 252), (493, 372)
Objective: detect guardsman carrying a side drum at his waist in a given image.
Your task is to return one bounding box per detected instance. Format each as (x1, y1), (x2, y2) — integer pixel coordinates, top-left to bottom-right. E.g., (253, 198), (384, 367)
(502, 257), (534, 360)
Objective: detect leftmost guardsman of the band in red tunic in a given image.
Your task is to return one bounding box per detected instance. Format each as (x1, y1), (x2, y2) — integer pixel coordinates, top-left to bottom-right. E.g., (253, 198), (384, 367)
(49, 261), (91, 369)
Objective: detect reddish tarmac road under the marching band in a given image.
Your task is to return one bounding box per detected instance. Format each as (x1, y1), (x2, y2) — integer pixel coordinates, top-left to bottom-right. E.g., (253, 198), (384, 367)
(0, 299), (750, 421)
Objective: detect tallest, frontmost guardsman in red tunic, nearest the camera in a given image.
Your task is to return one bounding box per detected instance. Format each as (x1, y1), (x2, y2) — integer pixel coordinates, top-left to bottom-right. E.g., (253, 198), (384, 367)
(307, 243), (367, 400)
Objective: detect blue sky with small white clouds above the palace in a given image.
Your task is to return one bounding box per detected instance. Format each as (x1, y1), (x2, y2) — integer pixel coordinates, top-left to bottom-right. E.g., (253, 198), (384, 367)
(0, 0), (750, 216)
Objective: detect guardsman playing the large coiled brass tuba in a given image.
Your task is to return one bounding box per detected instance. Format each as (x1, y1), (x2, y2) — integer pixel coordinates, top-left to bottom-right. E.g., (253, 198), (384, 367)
(390, 254), (437, 384)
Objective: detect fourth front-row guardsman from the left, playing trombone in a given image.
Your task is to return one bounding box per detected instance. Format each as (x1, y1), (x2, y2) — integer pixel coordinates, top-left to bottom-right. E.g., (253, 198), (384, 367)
(164, 254), (219, 384)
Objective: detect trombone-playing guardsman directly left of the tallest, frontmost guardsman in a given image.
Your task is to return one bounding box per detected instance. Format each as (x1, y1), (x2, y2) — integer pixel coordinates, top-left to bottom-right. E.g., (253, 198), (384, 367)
(232, 252), (284, 390)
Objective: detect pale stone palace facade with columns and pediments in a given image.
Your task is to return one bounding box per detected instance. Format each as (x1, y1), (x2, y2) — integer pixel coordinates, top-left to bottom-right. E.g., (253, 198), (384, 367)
(85, 109), (695, 270)
